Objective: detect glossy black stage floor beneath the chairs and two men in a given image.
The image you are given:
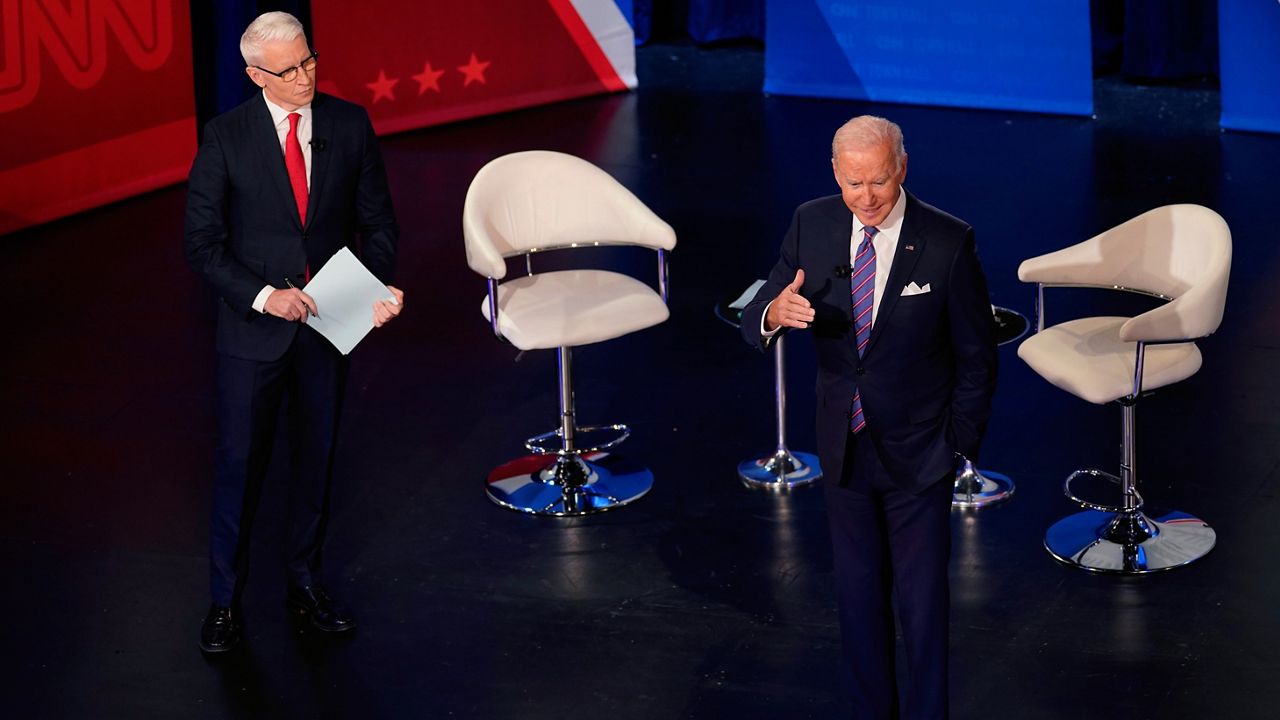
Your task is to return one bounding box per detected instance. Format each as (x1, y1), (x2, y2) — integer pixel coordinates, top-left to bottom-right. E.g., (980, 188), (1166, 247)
(0, 46), (1280, 720)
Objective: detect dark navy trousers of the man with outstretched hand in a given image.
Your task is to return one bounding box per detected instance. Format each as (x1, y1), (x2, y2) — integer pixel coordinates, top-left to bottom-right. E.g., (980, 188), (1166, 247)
(824, 432), (954, 720)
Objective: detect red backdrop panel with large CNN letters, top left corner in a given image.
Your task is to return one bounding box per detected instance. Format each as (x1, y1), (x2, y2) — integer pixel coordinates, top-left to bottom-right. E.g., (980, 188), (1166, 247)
(0, 0), (196, 233)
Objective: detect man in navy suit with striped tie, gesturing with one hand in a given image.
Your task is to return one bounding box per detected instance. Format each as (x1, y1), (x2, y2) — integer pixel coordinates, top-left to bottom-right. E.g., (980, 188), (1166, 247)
(742, 115), (996, 720)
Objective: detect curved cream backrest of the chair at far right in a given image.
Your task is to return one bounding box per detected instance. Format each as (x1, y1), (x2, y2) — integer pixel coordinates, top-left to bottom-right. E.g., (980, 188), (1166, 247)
(1018, 205), (1231, 341)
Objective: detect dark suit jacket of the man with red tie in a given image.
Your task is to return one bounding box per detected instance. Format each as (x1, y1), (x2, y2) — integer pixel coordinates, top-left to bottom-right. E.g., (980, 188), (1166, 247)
(186, 92), (399, 361)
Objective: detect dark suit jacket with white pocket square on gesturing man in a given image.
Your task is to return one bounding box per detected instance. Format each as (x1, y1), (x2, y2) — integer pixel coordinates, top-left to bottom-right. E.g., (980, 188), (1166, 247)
(742, 188), (996, 492)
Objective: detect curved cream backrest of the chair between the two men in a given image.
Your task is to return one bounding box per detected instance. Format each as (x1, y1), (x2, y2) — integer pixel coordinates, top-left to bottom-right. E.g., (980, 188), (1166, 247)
(462, 150), (676, 279)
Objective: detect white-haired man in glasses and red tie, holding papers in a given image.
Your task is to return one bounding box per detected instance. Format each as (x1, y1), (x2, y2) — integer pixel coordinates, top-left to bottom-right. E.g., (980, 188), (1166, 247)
(186, 13), (404, 652)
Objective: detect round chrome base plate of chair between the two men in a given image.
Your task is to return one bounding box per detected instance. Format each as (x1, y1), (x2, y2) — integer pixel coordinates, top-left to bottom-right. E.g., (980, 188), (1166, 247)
(485, 452), (653, 518)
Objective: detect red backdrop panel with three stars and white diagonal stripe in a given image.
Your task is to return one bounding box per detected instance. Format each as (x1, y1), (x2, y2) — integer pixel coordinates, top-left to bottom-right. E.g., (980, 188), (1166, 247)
(311, 0), (634, 133)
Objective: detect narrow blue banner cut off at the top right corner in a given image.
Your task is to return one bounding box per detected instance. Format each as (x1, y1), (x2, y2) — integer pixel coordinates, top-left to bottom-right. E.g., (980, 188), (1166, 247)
(1217, 0), (1280, 132)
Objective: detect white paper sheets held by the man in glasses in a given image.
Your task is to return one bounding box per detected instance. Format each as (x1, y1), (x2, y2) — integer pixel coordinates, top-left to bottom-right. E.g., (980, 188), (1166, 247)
(302, 247), (396, 355)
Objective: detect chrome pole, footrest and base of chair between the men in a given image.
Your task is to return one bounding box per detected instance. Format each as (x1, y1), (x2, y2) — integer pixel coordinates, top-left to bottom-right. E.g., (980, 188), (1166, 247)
(485, 347), (653, 518)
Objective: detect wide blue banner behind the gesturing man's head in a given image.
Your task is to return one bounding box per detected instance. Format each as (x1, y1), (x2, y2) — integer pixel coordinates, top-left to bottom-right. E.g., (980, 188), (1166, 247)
(764, 0), (1093, 115)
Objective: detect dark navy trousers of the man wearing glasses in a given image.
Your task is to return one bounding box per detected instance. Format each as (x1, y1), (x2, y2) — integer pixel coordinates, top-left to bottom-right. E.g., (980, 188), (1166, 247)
(209, 327), (348, 606)
